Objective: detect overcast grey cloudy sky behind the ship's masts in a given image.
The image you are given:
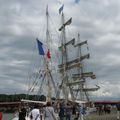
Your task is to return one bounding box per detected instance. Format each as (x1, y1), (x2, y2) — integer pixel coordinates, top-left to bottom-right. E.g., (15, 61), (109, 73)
(0, 0), (120, 98)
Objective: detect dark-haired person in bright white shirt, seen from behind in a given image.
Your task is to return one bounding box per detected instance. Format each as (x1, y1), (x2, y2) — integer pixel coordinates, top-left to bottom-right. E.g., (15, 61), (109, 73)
(30, 104), (40, 120)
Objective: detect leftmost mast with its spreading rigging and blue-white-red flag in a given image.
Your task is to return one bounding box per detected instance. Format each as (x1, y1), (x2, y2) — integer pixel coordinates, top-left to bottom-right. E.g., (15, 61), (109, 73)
(26, 6), (57, 101)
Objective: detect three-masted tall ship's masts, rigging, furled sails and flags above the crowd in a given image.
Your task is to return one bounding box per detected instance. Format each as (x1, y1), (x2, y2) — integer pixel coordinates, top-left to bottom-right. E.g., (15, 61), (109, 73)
(23, 5), (100, 104)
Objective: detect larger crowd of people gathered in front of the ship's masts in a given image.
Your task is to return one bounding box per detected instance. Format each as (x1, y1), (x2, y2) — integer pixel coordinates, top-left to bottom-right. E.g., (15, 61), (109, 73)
(16, 101), (85, 120)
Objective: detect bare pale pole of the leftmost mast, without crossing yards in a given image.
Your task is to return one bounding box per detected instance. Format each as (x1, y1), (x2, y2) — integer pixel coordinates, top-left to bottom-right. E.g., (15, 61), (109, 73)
(39, 6), (56, 101)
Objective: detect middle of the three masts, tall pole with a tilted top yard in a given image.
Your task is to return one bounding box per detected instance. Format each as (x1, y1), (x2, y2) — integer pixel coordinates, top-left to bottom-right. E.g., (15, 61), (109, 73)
(59, 12), (74, 102)
